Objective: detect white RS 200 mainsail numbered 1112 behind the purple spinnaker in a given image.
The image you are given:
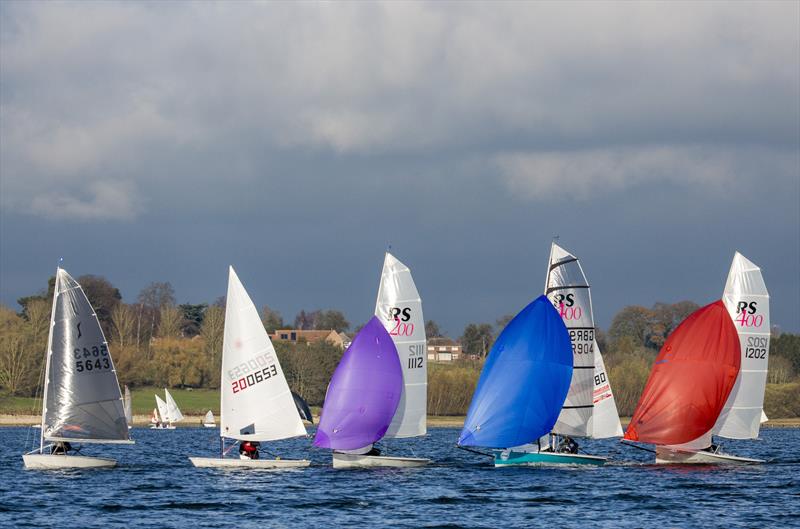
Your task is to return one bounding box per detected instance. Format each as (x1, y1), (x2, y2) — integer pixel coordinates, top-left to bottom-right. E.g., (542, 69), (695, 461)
(375, 252), (428, 437)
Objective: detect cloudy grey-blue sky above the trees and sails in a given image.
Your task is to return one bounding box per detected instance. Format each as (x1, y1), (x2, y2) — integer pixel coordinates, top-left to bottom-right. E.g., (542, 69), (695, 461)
(0, 1), (800, 337)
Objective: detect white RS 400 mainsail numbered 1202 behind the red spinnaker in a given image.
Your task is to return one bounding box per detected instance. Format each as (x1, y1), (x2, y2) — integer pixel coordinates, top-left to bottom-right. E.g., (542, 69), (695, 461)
(713, 252), (770, 439)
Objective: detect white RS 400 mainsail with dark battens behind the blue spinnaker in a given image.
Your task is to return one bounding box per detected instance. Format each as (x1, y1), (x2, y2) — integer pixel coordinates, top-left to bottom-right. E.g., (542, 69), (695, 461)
(545, 243), (595, 437)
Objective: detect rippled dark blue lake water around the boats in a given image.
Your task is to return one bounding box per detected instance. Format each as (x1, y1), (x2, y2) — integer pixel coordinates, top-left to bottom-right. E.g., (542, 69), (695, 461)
(0, 428), (800, 529)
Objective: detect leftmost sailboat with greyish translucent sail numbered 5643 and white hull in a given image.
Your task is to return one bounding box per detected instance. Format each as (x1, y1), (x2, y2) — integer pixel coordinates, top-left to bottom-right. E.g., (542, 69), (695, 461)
(22, 268), (133, 469)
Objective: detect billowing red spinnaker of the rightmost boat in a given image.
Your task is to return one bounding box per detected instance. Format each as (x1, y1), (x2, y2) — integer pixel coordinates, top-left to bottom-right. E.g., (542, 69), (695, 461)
(625, 301), (741, 445)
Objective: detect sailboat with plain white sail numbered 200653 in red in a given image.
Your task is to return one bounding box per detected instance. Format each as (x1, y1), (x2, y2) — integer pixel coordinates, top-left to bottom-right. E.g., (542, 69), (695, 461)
(189, 267), (311, 468)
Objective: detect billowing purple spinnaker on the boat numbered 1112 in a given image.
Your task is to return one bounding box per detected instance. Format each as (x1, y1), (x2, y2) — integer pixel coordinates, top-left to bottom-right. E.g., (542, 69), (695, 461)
(314, 316), (403, 450)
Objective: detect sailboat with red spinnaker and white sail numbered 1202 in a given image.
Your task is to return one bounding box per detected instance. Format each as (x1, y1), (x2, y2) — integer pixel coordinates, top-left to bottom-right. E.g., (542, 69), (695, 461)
(625, 252), (769, 464)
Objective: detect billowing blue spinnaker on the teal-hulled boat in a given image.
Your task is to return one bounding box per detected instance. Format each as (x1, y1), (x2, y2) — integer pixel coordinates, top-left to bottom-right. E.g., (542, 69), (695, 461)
(458, 296), (572, 448)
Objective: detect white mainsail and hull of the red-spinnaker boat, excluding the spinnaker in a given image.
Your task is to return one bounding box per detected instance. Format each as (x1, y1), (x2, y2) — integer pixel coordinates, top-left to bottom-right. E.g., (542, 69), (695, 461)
(656, 252), (770, 464)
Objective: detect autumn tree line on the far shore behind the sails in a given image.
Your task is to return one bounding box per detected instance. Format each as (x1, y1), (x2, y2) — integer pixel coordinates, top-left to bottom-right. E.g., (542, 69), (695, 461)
(0, 275), (800, 416)
